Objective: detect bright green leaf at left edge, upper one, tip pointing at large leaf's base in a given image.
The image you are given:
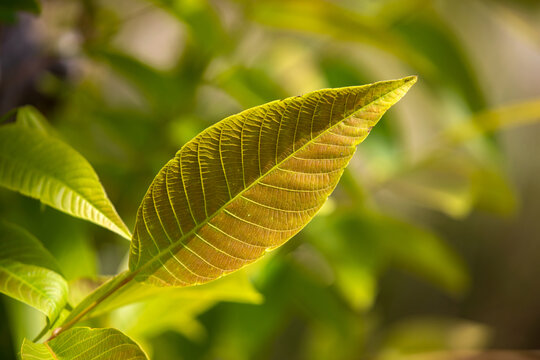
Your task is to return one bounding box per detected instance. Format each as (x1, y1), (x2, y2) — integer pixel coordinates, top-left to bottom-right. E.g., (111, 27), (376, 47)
(0, 124), (131, 239)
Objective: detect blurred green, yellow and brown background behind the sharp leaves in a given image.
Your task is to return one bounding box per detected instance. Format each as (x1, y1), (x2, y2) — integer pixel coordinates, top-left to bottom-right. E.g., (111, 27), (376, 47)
(0, 0), (540, 360)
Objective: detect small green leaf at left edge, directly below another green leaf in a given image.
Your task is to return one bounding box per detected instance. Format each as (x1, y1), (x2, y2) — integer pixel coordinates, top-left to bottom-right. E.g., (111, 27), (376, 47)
(0, 220), (68, 323)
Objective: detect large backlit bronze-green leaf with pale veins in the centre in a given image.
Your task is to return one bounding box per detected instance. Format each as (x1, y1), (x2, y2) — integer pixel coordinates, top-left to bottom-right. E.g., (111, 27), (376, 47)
(129, 77), (416, 286)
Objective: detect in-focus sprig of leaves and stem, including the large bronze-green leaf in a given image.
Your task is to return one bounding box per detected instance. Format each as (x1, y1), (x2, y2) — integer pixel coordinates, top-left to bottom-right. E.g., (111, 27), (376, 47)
(0, 77), (416, 359)
